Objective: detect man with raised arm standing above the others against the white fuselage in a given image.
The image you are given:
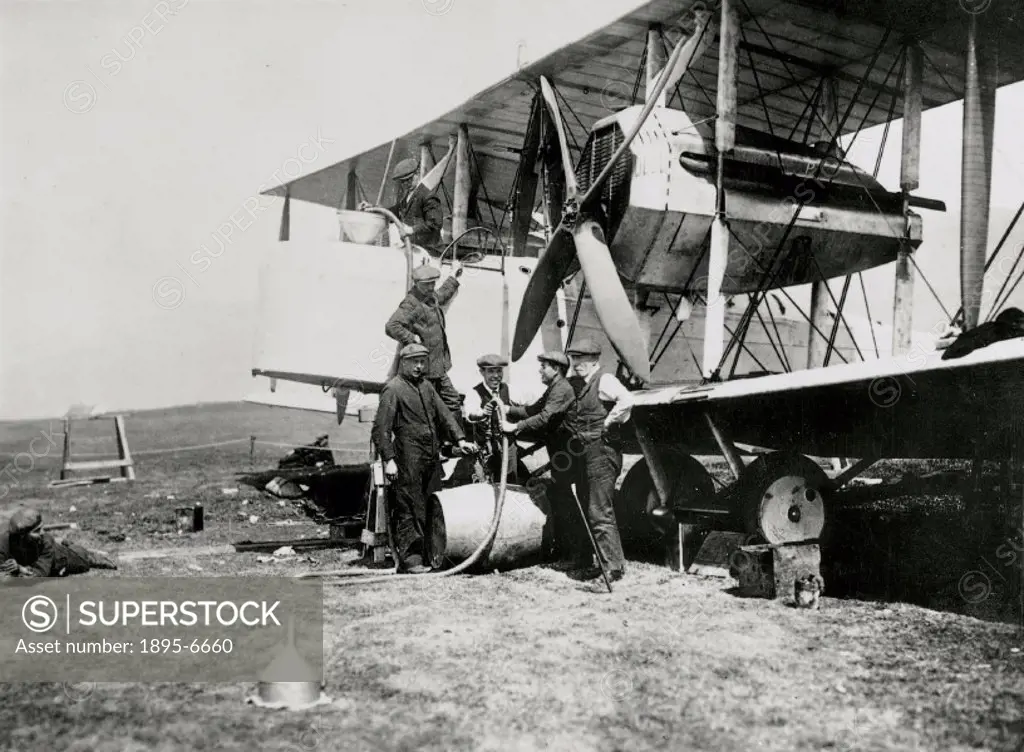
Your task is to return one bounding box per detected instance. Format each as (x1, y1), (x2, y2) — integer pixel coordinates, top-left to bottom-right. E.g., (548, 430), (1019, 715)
(384, 262), (462, 420)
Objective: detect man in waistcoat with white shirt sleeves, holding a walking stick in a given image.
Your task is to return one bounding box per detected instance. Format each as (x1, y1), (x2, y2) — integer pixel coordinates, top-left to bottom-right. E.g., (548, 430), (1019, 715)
(565, 339), (633, 580)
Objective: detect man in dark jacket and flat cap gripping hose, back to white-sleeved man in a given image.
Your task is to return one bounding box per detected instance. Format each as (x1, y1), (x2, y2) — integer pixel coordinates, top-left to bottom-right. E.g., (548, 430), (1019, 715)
(503, 351), (590, 568)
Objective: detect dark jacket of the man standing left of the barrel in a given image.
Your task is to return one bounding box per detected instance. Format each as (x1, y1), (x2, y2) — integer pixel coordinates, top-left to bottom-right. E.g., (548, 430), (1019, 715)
(371, 375), (466, 462)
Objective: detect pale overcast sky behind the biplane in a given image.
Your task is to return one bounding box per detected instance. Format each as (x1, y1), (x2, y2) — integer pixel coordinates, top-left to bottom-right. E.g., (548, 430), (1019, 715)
(0, 0), (1024, 418)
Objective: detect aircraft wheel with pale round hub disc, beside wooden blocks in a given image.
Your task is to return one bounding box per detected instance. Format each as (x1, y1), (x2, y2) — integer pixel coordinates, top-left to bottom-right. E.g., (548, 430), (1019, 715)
(733, 452), (828, 544)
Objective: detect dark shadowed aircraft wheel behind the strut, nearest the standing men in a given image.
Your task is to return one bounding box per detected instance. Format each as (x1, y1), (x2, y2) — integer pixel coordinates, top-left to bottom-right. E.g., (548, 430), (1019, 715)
(615, 449), (715, 553)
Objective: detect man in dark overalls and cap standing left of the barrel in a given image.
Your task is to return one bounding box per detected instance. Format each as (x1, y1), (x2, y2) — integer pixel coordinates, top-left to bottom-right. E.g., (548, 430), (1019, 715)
(371, 343), (474, 574)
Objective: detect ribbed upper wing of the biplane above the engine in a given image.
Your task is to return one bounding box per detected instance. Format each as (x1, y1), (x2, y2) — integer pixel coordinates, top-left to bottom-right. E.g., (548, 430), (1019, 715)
(264, 0), (1024, 213)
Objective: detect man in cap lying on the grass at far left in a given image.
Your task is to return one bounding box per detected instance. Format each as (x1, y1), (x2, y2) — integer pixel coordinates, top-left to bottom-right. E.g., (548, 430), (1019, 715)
(0, 509), (118, 577)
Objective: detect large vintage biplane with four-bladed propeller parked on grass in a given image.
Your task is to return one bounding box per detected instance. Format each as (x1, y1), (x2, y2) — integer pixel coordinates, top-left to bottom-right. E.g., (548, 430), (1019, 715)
(253, 0), (1024, 565)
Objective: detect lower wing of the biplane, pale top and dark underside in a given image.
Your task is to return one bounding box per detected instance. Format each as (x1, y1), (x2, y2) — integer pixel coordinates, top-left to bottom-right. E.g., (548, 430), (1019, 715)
(633, 338), (1024, 458)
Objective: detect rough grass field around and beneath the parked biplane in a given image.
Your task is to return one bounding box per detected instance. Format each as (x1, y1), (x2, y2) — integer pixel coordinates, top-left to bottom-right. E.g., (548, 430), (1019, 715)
(0, 404), (1024, 752)
